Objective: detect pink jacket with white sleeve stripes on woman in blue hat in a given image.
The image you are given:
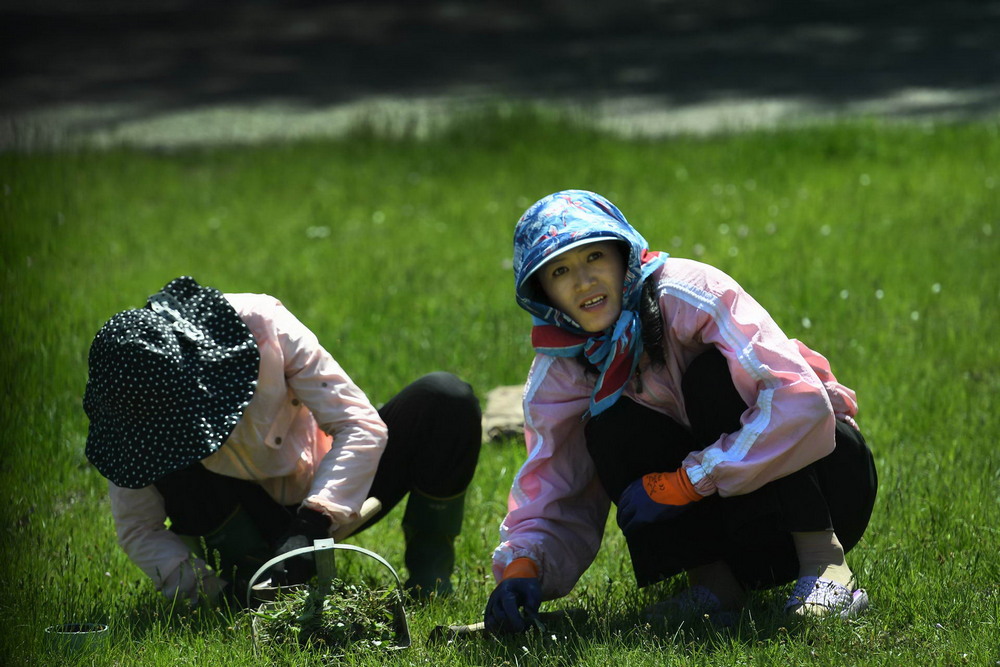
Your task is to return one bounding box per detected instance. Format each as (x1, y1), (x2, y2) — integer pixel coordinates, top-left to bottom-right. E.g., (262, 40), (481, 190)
(493, 258), (857, 599)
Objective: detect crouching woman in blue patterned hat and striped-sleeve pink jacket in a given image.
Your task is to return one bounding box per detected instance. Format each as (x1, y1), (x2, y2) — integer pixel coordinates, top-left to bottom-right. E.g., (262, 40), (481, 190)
(485, 190), (877, 633)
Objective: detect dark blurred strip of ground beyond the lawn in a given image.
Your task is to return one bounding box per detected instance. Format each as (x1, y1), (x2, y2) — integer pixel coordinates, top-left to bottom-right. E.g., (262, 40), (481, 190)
(0, 0), (1000, 146)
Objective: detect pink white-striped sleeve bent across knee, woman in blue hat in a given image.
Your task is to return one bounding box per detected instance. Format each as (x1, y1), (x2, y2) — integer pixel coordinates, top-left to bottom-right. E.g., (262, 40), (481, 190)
(659, 262), (835, 496)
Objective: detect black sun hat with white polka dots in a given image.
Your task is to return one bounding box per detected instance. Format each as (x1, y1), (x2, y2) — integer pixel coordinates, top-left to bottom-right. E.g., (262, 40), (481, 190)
(83, 276), (260, 489)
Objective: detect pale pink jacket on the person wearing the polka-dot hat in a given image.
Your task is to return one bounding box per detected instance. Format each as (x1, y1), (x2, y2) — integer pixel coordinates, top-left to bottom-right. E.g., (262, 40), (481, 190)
(109, 294), (388, 598)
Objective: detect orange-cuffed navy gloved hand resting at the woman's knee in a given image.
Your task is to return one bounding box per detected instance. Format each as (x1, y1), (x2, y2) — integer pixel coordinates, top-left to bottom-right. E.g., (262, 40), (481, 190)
(618, 468), (704, 537)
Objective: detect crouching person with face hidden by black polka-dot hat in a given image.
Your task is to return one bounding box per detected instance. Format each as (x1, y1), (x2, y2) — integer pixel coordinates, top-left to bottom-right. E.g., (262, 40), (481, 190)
(83, 276), (481, 605)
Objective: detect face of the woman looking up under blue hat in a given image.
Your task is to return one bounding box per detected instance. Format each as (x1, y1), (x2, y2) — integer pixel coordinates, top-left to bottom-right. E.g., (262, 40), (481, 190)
(538, 241), (625, 333)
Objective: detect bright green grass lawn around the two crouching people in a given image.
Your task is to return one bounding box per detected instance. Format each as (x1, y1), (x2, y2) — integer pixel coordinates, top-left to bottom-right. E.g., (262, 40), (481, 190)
(0, 113), (1000, 665)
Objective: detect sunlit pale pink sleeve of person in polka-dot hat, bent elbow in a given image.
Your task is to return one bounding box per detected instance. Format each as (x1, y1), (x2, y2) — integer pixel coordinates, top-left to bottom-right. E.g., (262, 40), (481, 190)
(274, 303), (388, 527)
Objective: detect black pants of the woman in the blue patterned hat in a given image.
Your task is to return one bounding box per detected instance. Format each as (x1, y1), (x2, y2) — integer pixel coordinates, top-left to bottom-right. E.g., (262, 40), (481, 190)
(586, 350), (878, 588)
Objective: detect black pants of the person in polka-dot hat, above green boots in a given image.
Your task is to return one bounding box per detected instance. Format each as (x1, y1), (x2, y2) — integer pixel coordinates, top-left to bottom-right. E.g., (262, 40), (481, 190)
(155, 372), (482, 548)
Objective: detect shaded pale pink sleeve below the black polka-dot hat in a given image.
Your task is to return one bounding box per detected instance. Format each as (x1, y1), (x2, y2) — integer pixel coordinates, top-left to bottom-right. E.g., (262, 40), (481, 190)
(108, 482), (224, 602)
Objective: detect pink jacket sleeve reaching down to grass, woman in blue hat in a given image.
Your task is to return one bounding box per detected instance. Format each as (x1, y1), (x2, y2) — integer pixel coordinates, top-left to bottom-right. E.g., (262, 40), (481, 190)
(493, 355), (610, 599)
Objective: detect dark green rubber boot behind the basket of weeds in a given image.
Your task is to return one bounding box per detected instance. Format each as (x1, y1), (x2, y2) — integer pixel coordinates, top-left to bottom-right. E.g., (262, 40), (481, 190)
(403, 489), (465, 599)
